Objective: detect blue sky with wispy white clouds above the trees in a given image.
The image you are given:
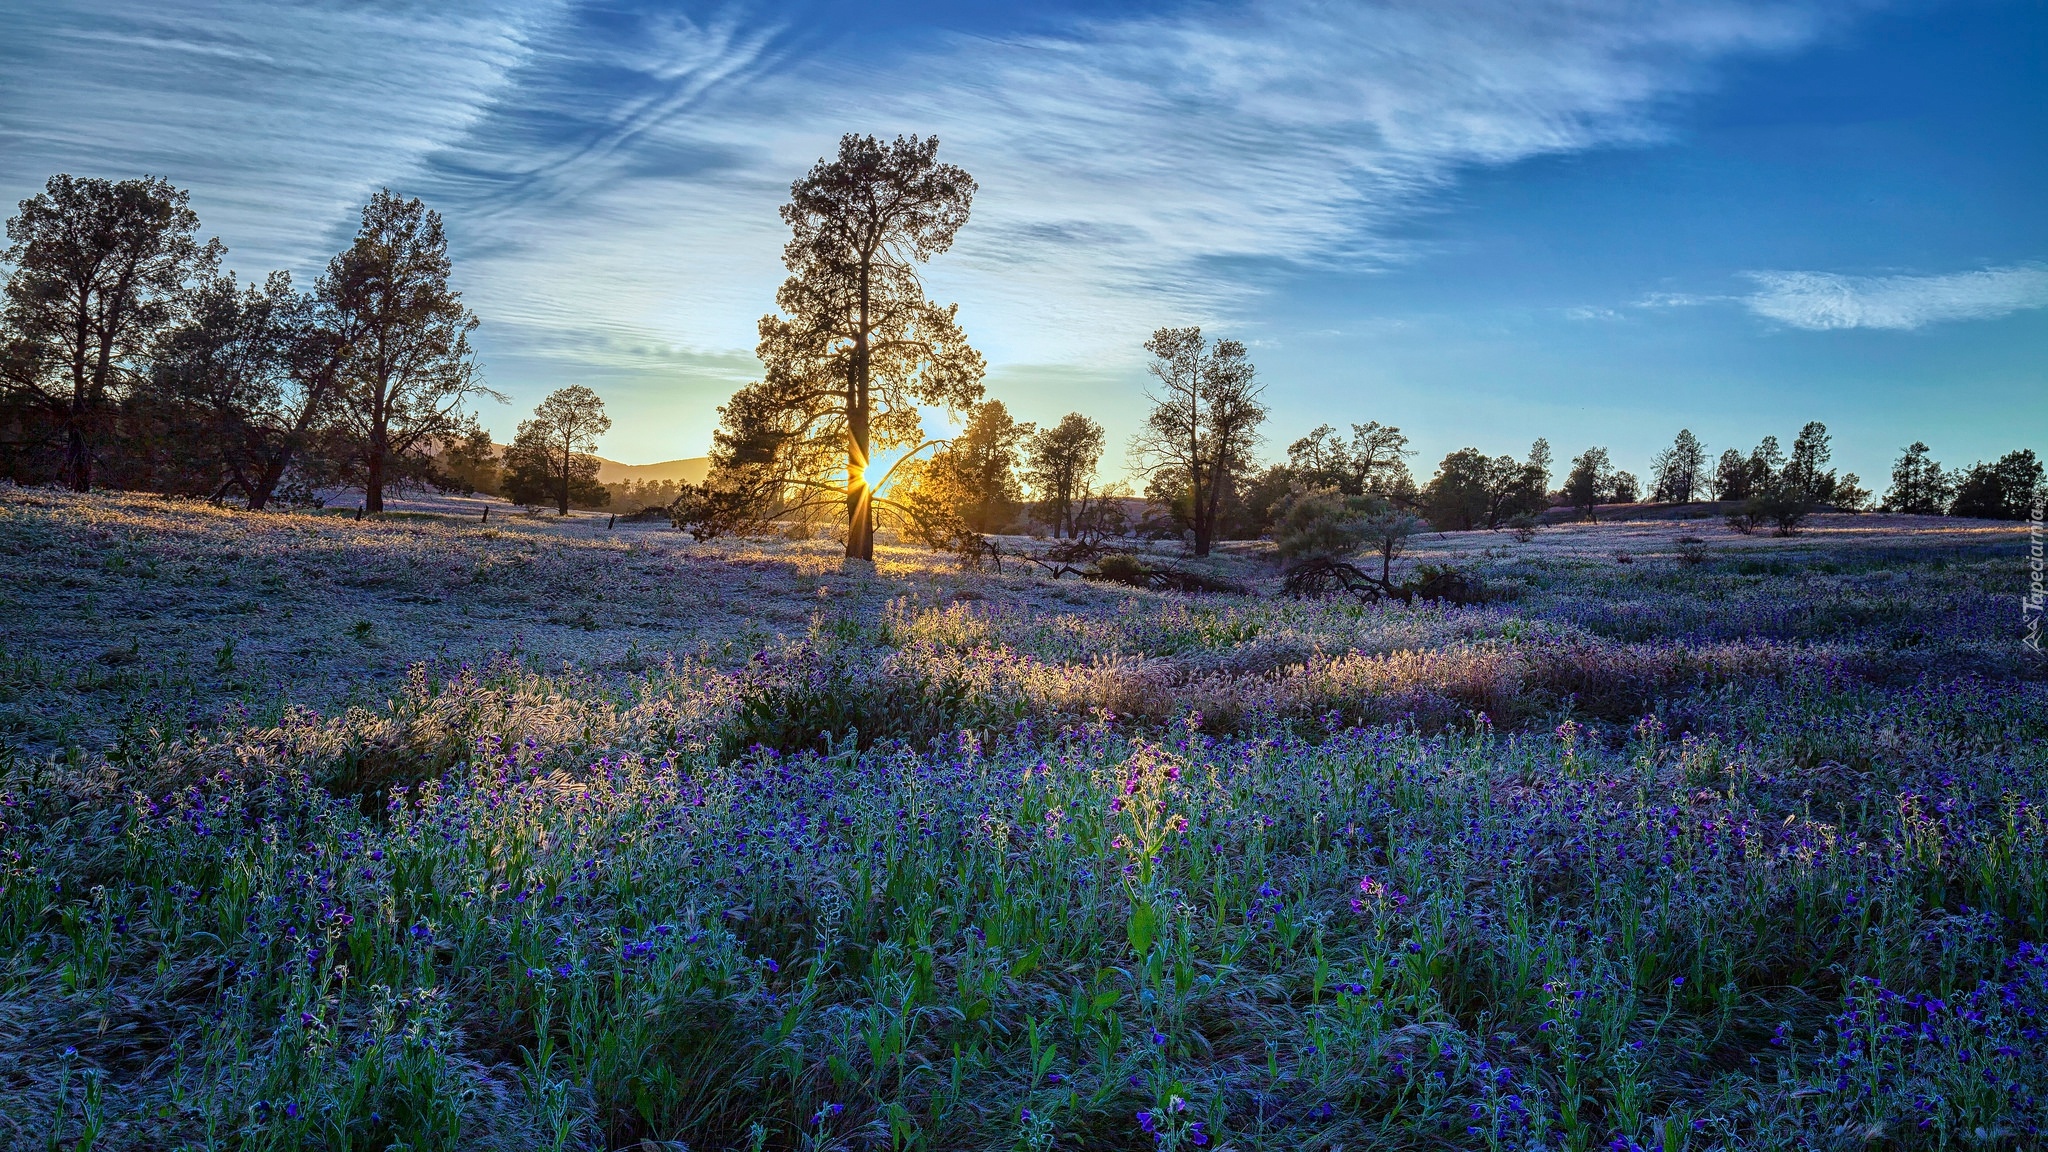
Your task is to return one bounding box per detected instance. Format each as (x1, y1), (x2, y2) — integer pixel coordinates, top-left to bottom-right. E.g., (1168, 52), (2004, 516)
(0, 0), (2048, 479)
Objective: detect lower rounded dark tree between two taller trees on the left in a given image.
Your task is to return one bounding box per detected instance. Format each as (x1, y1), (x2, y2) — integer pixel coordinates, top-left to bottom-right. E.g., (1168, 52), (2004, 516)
(143, 273), (340, 510)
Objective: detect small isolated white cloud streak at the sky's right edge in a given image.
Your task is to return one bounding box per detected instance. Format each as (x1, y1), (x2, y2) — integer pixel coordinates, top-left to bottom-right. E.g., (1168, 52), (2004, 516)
(1743, 264), (2048, 330)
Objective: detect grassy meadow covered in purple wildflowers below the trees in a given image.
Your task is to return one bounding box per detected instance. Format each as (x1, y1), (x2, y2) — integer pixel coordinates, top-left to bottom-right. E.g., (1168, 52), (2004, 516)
(0, 490), (2048, 1152)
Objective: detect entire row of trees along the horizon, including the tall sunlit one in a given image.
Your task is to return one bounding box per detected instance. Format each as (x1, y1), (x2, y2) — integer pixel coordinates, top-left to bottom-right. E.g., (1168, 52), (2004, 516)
(0, 162), (2044, 545)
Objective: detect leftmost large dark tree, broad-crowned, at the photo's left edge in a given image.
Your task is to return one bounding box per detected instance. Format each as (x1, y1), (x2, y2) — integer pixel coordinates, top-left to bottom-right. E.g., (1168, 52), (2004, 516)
(0, 174), (221, 492)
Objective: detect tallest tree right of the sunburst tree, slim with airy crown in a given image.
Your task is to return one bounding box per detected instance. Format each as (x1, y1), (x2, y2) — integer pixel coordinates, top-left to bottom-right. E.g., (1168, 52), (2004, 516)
(1130, 328), (1266, 556)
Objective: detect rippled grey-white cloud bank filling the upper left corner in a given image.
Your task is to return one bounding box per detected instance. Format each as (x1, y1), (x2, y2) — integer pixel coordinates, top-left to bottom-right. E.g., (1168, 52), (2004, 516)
(0, 0), (557, 262)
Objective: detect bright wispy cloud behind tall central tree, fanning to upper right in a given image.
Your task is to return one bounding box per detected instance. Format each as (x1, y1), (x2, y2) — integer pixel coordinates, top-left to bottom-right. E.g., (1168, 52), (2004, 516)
(436, 0), (1821, 363)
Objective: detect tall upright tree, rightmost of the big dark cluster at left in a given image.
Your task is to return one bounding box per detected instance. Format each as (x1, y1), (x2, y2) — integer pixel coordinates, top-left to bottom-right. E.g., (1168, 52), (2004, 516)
(317, 189), (498, 512)
